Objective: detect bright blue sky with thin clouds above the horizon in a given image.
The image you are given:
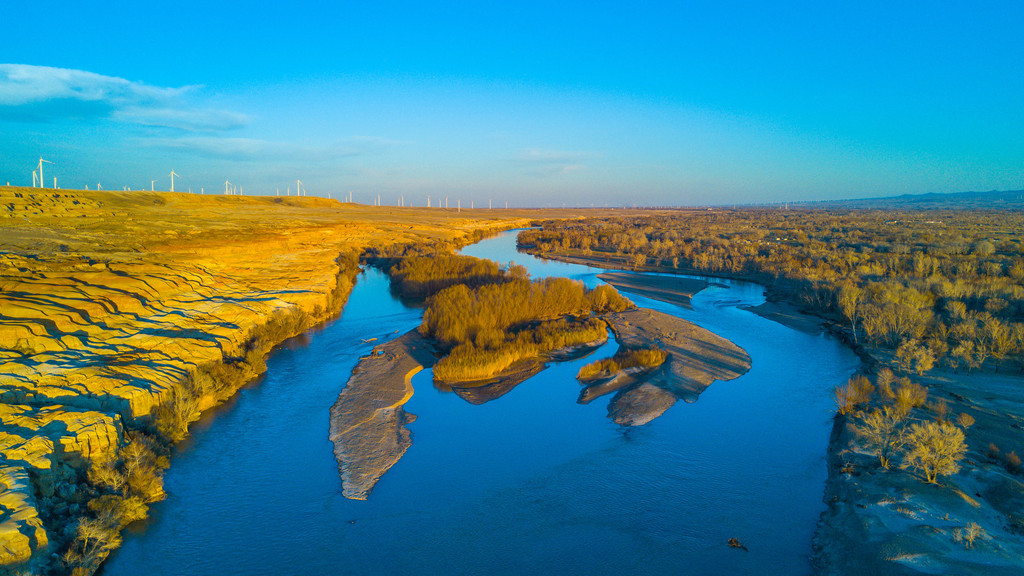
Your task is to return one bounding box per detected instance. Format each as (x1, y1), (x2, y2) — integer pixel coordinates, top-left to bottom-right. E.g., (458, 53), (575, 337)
(0, 0), (1024, 206)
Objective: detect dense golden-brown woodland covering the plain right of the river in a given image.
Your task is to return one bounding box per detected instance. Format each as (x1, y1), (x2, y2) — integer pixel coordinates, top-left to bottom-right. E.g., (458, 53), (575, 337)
(519, 209), (1024, 373)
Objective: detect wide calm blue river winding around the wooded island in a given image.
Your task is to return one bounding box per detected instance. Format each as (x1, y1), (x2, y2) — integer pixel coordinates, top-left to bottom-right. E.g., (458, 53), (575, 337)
(103, 228), (858, 576)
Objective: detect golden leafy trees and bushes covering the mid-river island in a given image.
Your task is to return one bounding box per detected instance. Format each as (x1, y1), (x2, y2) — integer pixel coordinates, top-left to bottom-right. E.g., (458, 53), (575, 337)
(376, 250), (633, 382)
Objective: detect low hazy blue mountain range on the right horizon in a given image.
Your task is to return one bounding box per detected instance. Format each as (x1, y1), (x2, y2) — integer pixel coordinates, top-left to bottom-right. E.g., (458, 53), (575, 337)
(790, 190), (1024, 210)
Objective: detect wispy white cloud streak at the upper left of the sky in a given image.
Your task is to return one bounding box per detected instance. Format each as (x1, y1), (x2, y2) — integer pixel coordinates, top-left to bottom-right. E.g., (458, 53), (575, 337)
(0, 64), (249, 131)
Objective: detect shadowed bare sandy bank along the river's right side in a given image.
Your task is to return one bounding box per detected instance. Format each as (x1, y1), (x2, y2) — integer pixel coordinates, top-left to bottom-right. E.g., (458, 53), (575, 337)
(532, 249), (1024, 575)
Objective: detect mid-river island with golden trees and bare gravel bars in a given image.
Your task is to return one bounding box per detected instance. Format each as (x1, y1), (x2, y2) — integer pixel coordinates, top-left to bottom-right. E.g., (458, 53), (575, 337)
(331, 246), (750, 499)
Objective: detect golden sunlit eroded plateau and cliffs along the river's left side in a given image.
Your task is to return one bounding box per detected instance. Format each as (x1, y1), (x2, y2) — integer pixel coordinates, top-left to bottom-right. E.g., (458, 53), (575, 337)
(0, 187), (527, 572)
